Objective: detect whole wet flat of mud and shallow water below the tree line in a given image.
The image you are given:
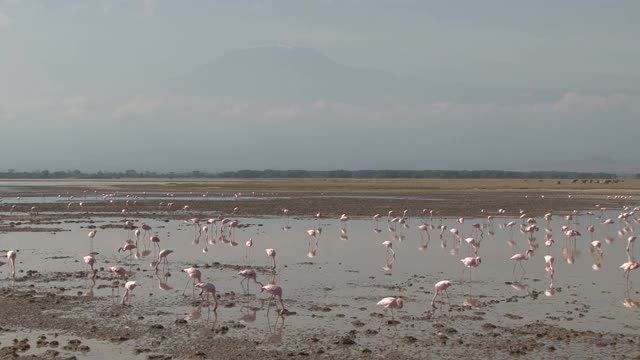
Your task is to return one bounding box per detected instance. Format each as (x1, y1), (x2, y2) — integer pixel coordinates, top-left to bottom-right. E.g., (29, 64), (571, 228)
(0, 180), (640, 359)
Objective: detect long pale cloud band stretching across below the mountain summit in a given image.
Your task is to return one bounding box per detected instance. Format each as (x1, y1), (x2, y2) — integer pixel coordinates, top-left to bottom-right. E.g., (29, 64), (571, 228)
(5, 92), (640, 133)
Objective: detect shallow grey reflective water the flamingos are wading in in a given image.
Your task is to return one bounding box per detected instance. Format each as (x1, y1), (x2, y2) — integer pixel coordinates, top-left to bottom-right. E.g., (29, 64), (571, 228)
(0, 204), (640, 344)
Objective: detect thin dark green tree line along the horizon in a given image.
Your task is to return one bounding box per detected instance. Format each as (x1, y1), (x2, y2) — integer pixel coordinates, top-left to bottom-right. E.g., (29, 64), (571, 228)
(0, 169), (624, 179)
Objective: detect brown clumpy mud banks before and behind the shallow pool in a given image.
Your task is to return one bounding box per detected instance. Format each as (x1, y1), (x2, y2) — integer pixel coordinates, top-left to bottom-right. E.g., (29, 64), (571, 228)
(0, 184), (640, 359)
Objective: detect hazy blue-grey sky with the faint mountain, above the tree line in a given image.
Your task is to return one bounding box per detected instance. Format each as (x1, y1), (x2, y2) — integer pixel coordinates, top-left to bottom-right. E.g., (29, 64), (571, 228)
(0, 0), (640, 173)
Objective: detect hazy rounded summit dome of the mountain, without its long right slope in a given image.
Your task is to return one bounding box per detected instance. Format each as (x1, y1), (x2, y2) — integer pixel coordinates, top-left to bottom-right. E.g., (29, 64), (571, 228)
(172, 47), (411, 103)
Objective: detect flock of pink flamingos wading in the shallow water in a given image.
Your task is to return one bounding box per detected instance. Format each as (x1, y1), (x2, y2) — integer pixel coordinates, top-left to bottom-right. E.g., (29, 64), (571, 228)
(0, 191), (640, 332)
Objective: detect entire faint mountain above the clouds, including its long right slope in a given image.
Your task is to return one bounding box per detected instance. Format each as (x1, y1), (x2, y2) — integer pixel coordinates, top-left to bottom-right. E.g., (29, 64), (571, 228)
(169, 46), (561, 104)
